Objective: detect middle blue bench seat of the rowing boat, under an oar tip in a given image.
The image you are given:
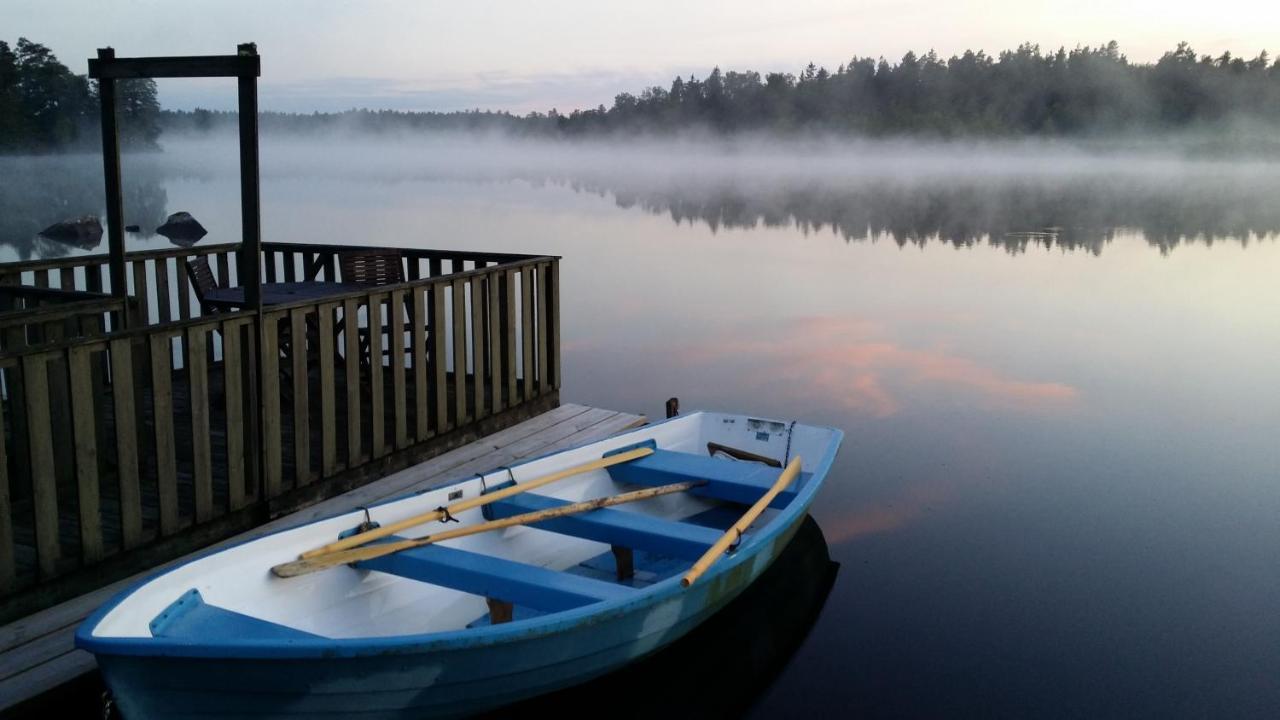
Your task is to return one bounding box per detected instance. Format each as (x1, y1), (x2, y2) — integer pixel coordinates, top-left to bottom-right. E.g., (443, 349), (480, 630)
(484, 492), (722, 560)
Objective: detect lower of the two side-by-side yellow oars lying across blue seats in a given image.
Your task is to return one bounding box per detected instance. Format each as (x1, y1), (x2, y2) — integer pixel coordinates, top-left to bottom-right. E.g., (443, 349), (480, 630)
(271, 480), (707, 578)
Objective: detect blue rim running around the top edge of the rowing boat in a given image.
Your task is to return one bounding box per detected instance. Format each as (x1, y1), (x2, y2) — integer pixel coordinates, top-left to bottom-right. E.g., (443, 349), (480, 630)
(76, 411), (845, 660)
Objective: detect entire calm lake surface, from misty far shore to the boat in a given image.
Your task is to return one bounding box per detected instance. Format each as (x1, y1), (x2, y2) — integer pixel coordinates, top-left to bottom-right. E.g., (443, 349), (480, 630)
(0, 137), (1280, 717)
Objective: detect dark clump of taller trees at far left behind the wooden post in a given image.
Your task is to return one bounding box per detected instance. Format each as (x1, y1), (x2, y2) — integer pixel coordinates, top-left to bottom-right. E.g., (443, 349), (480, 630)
(0, 37), (160, 154)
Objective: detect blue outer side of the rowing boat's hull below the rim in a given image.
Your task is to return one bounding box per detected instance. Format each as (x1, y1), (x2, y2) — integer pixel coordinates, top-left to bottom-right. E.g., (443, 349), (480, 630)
(97, 512), (808, 720)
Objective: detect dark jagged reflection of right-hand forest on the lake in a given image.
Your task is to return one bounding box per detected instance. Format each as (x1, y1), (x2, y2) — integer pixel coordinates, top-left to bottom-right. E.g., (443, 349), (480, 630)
(565, 173), (1280, 255)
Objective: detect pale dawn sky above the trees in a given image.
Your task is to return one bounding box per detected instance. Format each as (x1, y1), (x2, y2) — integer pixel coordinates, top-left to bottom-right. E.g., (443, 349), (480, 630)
(10, 0), (1280, 113)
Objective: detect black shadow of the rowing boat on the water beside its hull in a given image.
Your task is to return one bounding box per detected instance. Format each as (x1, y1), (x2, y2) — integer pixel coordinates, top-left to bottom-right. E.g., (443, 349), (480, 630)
(483, 516), (840, 720)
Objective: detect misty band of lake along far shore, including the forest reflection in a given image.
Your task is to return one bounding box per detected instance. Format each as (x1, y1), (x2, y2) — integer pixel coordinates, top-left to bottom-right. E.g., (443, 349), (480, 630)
(0, 133), (1280, 258)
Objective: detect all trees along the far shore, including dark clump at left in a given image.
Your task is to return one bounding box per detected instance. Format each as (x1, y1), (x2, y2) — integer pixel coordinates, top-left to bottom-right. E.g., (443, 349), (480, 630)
(0, 38), (1280, 152)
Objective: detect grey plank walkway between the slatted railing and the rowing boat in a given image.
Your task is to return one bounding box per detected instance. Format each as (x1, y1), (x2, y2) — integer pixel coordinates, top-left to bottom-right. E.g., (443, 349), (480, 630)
(0, 405), (645, 712)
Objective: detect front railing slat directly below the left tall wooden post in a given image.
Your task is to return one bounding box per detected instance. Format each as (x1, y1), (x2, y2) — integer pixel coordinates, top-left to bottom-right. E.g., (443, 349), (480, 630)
(110, 338), (142, 550)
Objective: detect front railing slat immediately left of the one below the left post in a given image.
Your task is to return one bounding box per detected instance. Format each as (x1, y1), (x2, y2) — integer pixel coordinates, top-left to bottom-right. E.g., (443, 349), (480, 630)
(67, 346), (104, 565)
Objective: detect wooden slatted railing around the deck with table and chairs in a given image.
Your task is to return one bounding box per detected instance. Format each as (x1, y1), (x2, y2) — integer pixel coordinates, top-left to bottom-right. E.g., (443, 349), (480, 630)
(0, 245), (561, 612)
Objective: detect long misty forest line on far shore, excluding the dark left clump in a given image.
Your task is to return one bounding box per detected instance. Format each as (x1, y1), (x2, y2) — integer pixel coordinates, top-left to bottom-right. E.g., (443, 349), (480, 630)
(164, 41), (1280, 137)
